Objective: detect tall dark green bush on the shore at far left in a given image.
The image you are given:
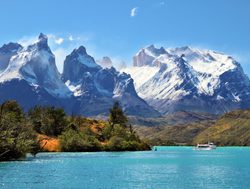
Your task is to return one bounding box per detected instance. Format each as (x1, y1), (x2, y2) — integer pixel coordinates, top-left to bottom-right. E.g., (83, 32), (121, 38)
(0, 101), (39, 161)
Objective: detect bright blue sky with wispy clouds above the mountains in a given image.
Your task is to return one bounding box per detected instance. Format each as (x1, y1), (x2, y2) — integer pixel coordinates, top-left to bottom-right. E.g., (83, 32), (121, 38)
(0, 0), (250, 76)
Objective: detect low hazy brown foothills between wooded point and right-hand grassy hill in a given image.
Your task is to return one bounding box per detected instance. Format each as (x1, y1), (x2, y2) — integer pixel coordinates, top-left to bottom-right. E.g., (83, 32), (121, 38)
(130, 112), (217, 145)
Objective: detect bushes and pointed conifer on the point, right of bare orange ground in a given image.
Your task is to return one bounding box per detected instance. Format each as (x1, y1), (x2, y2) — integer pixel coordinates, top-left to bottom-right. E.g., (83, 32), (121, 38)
(59, 102), (150, 151)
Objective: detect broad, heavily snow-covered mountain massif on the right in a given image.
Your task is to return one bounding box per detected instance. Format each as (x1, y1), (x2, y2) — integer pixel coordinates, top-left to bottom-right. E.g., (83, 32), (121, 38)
(122, 45), (250, 113)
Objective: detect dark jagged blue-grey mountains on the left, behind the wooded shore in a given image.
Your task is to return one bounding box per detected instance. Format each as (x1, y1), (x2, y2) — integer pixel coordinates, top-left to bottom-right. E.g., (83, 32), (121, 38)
(0, 33), (160, 117)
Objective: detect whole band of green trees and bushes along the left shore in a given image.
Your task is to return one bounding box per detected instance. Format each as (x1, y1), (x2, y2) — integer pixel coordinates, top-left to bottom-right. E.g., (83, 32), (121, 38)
(0, 101), (150, 161)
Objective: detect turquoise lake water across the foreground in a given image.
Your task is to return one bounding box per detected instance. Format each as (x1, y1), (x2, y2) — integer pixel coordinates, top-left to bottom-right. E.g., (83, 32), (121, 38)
(0, 147), (250, 189)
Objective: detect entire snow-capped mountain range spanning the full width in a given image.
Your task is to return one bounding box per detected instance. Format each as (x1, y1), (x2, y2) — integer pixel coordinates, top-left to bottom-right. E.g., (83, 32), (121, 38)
(0, 33), (250, 117)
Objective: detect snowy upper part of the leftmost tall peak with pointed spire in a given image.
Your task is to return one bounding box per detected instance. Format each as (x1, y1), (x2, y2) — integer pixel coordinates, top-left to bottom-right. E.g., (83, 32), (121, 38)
(0, 34), (71, 97)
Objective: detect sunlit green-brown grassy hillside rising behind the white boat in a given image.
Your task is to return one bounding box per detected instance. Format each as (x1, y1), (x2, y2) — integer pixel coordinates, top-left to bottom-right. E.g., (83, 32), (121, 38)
(193, 110), (250, 146)
